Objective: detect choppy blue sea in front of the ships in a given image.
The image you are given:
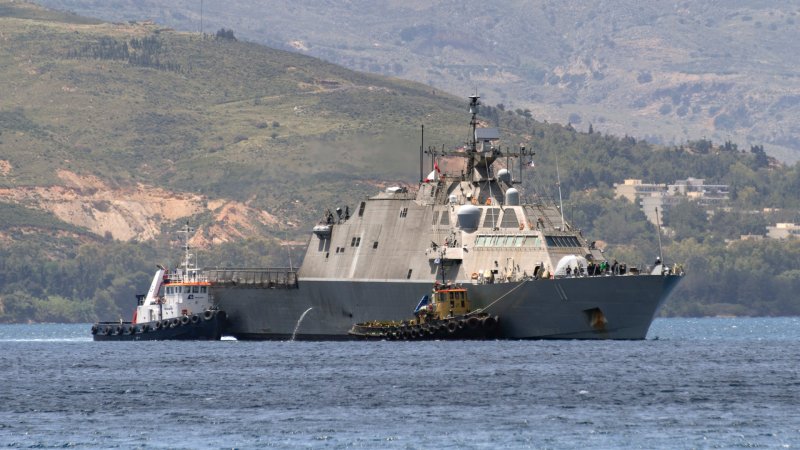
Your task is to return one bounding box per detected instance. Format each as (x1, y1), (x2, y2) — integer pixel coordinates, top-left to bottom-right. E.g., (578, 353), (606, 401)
(0, 318), (800, 449)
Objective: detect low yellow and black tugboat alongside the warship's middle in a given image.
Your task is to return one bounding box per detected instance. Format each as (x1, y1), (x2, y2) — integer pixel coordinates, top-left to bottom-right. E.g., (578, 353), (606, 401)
(348, 283), (499, 341)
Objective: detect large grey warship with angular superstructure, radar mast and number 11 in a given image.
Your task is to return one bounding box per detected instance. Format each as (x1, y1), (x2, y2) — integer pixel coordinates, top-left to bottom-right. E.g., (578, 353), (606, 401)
(205, 95), (682, 340)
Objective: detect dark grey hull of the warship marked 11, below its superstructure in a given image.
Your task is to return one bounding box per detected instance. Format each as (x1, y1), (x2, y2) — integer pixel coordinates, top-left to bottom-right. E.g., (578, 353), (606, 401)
(213, 275), (681, 340)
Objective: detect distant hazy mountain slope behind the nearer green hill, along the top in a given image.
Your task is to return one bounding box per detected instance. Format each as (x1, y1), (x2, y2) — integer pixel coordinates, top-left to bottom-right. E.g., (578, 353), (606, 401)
(34, 0), (800, 161)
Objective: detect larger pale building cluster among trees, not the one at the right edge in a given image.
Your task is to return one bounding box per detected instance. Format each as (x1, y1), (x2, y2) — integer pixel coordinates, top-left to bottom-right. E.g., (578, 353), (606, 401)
(615, 178), (730, 225)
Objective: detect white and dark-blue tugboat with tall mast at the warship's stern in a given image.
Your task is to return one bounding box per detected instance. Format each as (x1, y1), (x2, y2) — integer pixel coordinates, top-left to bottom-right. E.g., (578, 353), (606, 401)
(92, 224), (227, 341)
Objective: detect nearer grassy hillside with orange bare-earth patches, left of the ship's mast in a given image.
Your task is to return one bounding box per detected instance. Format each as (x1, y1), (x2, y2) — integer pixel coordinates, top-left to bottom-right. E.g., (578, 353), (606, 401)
(0, 0), (476, 246)
